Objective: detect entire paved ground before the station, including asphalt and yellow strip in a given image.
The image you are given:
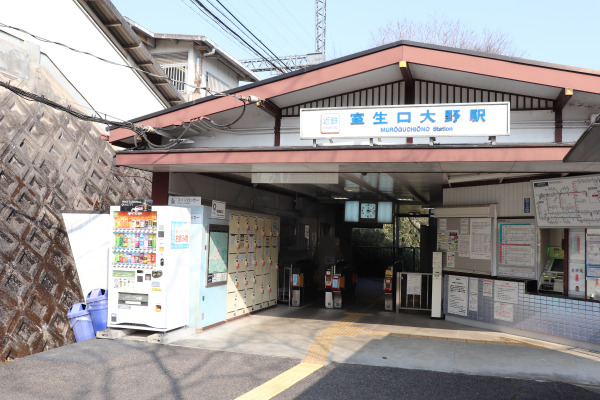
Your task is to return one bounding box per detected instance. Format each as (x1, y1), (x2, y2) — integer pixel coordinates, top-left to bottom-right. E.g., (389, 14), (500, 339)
(0, 278), (600, 400)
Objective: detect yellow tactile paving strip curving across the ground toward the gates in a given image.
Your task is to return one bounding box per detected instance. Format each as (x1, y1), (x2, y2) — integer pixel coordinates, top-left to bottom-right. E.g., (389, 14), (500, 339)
(236, 313), (373, 400)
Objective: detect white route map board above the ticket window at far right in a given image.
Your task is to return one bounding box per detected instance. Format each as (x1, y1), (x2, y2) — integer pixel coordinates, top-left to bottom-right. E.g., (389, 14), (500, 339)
(533, 175), (600, 228)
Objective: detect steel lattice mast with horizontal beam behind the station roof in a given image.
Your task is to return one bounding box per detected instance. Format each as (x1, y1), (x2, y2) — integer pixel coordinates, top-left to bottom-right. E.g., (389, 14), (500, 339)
(242, 0), (327, 72)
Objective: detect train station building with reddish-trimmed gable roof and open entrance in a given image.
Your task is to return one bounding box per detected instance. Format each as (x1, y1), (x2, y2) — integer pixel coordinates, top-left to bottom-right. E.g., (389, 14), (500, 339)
(109, 41), (600, 345)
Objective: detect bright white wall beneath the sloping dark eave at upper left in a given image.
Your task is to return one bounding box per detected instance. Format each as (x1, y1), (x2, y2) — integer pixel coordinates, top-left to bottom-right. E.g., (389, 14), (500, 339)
(1, 0), (165, 119)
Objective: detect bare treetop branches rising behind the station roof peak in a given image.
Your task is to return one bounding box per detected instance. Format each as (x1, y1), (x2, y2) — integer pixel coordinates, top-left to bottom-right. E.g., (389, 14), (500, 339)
(371, 15), (523, 57)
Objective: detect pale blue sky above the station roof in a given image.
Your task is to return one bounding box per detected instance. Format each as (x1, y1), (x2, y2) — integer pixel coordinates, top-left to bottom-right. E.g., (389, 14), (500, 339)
(112, 0), (600, 70)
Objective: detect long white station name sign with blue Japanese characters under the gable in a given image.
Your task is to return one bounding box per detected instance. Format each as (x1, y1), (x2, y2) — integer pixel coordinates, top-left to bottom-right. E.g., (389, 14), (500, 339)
(300, 102), (510, 139)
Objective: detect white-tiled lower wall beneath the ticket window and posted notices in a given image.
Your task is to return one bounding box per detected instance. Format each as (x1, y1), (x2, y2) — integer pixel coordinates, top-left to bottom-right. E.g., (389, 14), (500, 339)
(444, 275), (600, 344)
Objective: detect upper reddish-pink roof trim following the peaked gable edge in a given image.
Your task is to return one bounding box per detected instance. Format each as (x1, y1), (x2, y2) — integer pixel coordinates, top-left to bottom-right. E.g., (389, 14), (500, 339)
(110, 45), (600, 142)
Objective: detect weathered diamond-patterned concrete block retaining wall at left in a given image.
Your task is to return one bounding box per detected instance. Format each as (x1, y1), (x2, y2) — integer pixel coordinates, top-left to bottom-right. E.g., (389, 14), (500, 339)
(0, 81), (151, 362)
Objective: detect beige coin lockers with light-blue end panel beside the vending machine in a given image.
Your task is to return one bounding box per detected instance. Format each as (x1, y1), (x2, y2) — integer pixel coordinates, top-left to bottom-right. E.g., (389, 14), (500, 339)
(169, 196), (280, 329)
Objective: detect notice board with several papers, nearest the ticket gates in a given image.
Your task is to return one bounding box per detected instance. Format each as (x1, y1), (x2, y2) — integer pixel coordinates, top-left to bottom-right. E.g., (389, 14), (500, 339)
(437, 217), (495, 275)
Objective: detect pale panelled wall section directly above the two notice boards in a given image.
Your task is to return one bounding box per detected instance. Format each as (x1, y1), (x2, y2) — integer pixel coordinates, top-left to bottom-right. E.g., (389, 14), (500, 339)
(443, 182), (535, 218)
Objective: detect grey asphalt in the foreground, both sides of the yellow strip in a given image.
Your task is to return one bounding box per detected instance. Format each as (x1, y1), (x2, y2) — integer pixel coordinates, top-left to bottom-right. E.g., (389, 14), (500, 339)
(0, 339), (600, 400)
